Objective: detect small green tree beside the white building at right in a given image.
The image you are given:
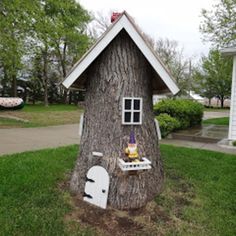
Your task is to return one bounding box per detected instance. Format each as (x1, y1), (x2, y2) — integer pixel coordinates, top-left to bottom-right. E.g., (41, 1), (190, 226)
(195, 49), (233, 108)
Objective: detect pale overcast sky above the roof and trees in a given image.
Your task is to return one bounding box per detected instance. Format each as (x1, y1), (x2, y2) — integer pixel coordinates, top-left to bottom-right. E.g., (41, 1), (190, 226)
(79, 0), (216, 57)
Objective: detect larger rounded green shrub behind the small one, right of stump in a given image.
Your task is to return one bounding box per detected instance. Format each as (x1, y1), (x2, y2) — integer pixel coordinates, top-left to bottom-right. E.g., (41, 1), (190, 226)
(154, 99), (203, 129)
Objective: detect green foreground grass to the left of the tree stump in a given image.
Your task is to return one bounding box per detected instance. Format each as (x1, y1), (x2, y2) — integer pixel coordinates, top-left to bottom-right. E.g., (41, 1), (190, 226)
(0, 146), (94, 235)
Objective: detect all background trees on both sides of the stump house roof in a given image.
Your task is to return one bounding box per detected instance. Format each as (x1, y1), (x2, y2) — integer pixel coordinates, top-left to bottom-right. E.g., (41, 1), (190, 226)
(0, 0), (236, 107)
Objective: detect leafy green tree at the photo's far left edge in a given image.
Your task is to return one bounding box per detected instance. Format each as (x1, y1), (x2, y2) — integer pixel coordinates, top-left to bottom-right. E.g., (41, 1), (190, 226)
(0, 0), (34, 96)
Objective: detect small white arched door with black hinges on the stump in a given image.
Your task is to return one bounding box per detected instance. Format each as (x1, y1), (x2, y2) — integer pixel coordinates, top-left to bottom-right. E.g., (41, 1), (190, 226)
(84, 166), (109, 209)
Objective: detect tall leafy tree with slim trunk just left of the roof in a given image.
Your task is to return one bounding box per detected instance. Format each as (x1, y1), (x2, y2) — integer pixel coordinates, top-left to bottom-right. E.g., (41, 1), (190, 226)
(34, 0), (90, 106)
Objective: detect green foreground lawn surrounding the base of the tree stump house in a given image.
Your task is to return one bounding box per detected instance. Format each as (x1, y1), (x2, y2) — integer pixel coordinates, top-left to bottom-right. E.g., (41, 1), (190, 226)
(0, 145), (236, 236)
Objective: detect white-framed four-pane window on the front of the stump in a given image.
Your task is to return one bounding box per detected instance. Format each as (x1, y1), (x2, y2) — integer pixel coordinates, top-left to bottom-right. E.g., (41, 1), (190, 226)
(122, 97), (143, 125)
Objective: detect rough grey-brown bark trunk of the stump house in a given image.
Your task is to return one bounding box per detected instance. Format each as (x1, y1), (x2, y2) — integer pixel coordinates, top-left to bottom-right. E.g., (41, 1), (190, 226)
(70, 30), (163, 209)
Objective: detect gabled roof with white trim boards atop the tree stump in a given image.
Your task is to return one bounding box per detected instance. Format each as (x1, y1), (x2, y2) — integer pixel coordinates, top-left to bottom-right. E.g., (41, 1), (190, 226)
(63, 11), (179, 94)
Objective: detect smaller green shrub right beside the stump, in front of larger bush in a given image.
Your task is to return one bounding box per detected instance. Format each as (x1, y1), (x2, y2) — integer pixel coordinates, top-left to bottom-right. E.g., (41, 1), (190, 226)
(156, 113), (180, 138)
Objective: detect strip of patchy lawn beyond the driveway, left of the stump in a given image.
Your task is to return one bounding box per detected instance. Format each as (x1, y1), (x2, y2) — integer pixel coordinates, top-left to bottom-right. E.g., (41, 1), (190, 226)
(0, 105), (83, 128)
